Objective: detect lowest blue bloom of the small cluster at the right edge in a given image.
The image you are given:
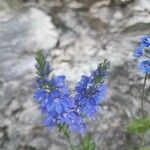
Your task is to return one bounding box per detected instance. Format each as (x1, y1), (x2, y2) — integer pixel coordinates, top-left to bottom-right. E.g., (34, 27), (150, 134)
(139, 60), (150, 73)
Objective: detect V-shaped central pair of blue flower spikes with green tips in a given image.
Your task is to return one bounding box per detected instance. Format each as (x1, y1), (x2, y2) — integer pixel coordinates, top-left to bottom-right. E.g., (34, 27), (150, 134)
(34, 51), (109, 134)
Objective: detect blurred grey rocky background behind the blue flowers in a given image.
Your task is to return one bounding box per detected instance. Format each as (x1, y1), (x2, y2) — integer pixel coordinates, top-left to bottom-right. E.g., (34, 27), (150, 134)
(0, 0), (150, 150)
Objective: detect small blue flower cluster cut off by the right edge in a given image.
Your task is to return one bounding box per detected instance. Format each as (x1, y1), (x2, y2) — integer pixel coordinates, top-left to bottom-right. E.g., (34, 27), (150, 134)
(134, 36), (150, 73)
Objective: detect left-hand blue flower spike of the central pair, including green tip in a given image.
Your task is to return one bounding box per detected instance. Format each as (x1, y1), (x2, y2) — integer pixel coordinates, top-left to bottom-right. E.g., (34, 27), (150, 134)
(34, 52), (86, 133)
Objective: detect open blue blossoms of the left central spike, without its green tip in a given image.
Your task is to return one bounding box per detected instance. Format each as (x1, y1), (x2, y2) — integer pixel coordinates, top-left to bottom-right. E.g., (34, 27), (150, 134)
(35, 77), (86, 134)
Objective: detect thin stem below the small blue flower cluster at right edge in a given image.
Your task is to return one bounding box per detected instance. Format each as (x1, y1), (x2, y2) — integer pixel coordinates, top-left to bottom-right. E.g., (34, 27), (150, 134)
(139, 73), (148, 148)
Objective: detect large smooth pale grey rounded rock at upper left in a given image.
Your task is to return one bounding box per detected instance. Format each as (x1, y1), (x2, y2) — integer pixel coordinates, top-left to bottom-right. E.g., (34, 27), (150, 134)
(0, 8), (58, 52)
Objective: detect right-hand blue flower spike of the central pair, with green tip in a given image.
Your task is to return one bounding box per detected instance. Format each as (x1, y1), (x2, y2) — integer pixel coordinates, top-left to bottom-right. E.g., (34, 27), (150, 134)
(75, 60), (110, 118)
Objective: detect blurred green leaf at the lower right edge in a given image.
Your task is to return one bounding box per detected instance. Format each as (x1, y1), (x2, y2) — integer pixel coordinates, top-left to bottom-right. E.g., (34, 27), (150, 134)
(127, 117), (150, 133)
